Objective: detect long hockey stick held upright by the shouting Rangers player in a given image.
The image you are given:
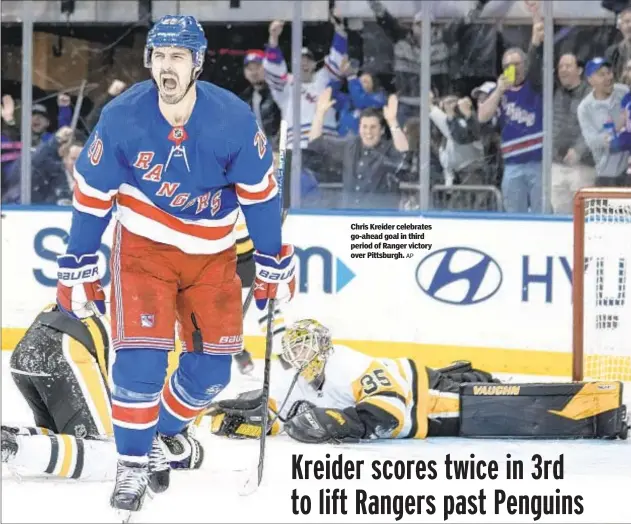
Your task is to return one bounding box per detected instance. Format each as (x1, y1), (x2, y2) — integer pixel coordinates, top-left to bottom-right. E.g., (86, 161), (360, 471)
(243, 120), (287, 495)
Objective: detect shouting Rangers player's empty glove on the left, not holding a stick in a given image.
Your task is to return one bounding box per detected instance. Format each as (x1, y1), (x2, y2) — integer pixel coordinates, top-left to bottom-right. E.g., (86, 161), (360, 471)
(57, 255), (105, 318)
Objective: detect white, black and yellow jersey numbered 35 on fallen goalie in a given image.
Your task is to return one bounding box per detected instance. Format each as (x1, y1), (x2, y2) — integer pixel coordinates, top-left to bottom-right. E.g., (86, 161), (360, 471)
(270, 345), (459, 438)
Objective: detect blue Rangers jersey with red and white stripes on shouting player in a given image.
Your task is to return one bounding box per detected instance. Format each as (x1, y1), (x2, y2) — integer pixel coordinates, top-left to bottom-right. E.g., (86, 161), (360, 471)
(67, 81), (281, 256)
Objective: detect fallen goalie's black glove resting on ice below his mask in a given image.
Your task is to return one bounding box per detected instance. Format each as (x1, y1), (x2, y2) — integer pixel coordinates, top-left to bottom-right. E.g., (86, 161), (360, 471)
(285, 407), (365, 444)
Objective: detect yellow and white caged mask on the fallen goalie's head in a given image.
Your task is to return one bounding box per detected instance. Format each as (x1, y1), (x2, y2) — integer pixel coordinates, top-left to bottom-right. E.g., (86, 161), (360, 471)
(279, 319), (333, 389)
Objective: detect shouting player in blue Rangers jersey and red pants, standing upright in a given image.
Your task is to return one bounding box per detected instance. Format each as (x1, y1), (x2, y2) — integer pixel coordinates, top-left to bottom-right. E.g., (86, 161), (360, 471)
(57, 16), (295, 512)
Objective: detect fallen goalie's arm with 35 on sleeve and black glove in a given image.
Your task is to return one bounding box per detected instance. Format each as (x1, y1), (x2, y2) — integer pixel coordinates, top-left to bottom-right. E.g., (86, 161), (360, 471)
(285, 360), (406, 444)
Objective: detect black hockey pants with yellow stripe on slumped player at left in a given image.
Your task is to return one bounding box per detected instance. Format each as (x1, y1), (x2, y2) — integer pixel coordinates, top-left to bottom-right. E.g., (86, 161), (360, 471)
(11, 305), (113, 437)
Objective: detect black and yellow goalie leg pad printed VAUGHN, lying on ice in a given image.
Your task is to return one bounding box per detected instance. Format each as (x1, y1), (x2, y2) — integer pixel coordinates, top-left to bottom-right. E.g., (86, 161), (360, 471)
(460, 381), (629, 439)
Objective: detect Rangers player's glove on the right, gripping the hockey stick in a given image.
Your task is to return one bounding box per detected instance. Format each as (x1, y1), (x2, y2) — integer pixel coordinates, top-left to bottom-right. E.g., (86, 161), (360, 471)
(254, 244), (296, 310)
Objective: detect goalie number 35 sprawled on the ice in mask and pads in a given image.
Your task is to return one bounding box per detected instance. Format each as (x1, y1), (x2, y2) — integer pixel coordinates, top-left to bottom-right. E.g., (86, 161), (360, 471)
(208, 320), (628, 443)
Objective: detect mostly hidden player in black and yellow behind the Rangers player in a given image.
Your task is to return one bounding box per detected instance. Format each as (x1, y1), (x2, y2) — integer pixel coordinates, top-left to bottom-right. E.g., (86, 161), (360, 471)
(234, 207), (285, 375)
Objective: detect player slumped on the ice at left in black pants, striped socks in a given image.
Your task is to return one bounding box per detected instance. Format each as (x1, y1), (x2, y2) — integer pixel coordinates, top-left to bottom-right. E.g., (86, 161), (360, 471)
(2, 304), (203, 482)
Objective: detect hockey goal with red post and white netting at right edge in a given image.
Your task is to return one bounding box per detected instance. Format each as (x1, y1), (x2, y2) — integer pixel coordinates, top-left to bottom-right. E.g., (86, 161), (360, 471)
(572, 188), (631, 387)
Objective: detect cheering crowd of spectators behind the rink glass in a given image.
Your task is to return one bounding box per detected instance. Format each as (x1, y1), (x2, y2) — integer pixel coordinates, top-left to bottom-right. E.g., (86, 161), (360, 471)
(2, 0), (631, 214)
